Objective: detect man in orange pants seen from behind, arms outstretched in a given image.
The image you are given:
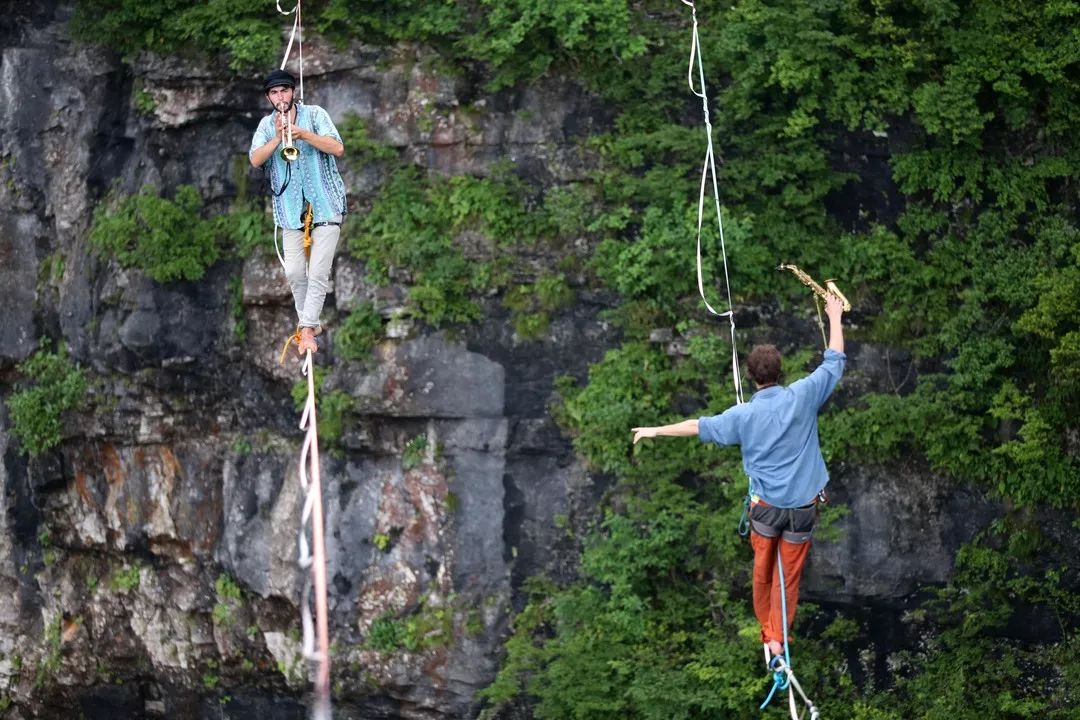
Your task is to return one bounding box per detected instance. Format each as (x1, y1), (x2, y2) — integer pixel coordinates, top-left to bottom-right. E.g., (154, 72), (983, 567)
(633, 293), (846, 656)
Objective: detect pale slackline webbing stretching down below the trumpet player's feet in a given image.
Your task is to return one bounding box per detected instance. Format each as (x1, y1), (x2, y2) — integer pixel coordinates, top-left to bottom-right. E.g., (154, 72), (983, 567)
(297, 350), (330, 720)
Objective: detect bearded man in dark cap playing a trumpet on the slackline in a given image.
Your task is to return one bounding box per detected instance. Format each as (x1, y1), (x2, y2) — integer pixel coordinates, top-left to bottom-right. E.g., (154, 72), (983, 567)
(248, 70), (346, 355)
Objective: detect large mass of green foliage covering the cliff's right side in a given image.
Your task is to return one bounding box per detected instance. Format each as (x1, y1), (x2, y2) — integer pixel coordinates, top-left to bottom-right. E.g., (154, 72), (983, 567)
(69, 0), (1080, 720)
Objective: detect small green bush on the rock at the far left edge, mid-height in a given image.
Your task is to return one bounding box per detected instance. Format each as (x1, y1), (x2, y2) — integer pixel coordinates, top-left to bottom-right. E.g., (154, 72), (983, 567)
(8, 342), (87, 456)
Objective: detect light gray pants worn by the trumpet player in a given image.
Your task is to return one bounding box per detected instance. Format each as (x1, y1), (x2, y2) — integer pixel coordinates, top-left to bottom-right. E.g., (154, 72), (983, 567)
(282, 215), (341, 327)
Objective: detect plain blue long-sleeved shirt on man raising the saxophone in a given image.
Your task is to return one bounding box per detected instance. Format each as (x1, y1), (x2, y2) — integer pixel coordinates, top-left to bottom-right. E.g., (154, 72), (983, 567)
(698, 350), (847, 507)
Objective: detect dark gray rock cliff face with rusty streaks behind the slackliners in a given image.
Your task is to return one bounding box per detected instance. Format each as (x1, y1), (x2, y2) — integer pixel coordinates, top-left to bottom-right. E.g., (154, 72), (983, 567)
(0, 2), (1010, 720)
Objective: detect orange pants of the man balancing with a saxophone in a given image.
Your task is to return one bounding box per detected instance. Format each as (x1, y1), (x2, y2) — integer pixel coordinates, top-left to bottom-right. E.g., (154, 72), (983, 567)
(750, 532), (810, 643)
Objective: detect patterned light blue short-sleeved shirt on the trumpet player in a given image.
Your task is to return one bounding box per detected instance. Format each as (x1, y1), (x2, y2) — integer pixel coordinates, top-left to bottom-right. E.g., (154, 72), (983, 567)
(247, 105), (346, 230)
